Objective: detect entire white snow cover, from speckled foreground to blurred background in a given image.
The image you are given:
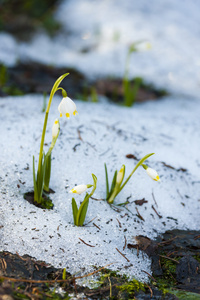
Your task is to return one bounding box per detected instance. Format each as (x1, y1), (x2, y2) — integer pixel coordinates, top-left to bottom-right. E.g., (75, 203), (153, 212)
(0, 0), (200, 281)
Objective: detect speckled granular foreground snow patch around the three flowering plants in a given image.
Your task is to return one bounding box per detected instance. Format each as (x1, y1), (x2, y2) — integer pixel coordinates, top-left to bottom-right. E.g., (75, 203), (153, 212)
(0, 95), (200, 281)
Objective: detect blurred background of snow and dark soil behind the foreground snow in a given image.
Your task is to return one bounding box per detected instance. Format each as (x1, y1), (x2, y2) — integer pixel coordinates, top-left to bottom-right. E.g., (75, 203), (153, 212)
(0, 0), (200, 102)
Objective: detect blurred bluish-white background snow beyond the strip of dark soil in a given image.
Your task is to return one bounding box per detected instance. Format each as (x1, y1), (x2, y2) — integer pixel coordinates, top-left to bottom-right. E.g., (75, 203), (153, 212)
(0, 0), (200, 95)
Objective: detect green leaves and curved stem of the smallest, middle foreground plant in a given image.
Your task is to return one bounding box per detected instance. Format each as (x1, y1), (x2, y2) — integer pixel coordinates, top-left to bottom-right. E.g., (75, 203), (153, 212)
(72, 174), (97, 226)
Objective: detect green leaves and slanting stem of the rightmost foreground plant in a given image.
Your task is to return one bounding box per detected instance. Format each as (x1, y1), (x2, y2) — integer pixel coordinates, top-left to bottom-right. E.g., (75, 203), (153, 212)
(105, 153), (154, 204)
